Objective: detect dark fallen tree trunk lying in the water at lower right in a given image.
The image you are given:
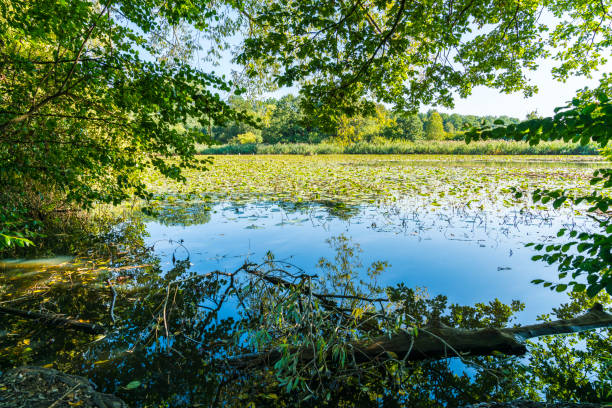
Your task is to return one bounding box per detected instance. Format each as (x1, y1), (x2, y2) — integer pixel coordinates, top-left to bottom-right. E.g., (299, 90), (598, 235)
(230, 303), (612, 368)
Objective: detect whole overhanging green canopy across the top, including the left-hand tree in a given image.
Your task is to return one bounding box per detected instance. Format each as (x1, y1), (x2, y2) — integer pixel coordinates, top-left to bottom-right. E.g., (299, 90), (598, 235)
(0, 0), (610, 212)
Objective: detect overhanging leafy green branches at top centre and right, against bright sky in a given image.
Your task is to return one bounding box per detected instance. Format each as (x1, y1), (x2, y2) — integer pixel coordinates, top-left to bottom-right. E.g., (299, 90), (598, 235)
(237, 0), (611, 122)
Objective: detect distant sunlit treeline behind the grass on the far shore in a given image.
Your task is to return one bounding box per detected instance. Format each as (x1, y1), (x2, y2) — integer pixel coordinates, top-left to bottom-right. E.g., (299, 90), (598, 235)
(209, 94), (520, 145)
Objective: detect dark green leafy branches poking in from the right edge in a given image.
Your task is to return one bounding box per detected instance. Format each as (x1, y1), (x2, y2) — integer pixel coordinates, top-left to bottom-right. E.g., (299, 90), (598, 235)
(466, 76), (612, 297)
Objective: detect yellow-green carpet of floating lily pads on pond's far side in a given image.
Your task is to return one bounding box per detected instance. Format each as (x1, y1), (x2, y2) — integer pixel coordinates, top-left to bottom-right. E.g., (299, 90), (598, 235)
(141, 155), (602, 215)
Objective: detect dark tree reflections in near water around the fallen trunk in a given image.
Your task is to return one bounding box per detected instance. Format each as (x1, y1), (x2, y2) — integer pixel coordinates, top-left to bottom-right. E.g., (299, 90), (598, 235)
(0, 225), (612, 407)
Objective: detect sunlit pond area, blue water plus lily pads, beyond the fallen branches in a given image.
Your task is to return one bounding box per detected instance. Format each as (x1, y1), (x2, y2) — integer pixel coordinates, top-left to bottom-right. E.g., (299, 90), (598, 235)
(147, 156), (601, 322)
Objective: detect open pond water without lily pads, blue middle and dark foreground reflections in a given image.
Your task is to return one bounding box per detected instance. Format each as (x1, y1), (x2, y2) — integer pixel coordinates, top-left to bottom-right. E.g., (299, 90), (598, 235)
(0, 156), (612, 407)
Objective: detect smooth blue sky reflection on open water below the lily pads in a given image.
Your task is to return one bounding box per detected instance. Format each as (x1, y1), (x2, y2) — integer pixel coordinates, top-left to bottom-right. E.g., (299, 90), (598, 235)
(147, 201), (589, 323)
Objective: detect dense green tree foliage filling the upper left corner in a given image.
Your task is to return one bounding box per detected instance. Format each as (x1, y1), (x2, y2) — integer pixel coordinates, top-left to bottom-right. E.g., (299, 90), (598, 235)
(0, 0), (245, 212)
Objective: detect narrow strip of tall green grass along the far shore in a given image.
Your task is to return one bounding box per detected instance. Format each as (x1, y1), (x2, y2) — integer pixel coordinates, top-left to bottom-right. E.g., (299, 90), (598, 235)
(200, 140), (599, 155)
